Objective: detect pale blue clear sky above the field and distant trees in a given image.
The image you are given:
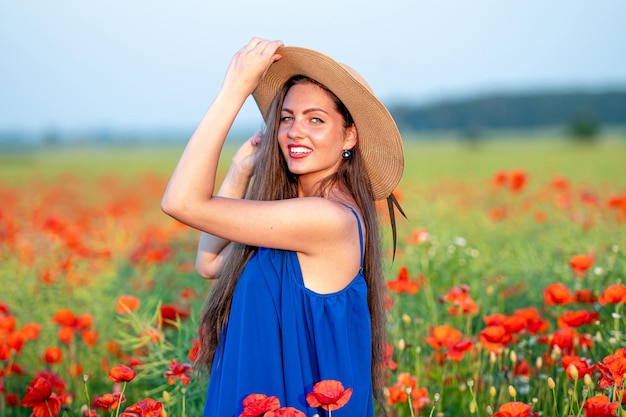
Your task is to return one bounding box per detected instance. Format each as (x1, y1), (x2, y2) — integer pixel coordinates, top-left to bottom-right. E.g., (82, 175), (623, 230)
(0, 0), (626, 132)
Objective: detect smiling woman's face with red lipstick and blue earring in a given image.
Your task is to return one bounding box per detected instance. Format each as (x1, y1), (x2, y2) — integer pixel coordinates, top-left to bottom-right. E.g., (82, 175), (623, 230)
(278, 83), (356, 183)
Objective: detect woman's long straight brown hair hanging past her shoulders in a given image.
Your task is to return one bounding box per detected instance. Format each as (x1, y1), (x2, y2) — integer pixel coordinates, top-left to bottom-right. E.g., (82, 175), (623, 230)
(196, 76), (386, 392)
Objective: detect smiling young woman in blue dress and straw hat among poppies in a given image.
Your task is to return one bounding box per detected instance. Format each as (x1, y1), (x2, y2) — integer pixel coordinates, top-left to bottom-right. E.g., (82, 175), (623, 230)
(162, 38), (404, 417)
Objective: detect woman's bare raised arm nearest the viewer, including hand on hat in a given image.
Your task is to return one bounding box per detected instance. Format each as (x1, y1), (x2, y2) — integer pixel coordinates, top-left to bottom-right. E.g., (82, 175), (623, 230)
(161, 39), (354, 255)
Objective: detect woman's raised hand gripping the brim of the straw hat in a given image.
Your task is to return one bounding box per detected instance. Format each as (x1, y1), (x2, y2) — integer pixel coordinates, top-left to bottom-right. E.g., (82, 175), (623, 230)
(217, 38), (283, 97)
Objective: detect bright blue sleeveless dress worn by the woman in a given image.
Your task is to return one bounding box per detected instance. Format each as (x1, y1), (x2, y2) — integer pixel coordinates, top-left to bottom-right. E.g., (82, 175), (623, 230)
(203, 207), (374, 417)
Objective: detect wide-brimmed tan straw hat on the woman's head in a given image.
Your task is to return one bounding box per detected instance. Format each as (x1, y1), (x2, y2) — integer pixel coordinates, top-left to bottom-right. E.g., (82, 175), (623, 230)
(253, 46), (404, 200)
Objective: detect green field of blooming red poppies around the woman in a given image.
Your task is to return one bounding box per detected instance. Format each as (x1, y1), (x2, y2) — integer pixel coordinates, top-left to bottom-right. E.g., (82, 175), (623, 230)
(0, 137), (626, 417)
